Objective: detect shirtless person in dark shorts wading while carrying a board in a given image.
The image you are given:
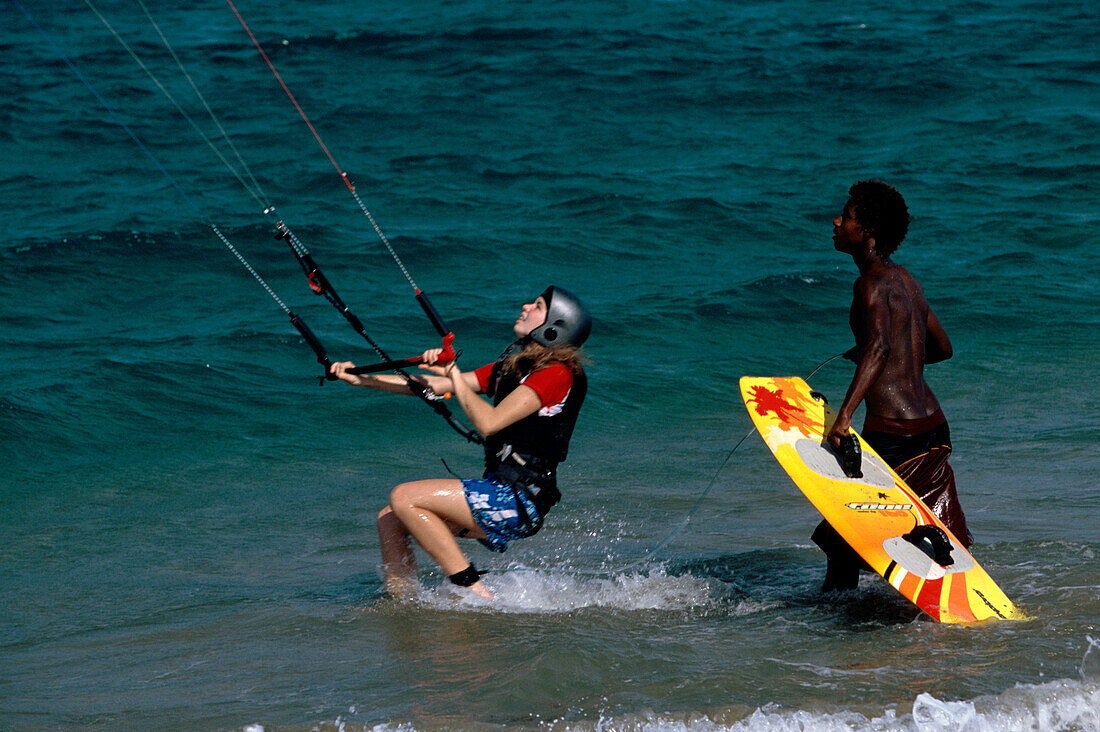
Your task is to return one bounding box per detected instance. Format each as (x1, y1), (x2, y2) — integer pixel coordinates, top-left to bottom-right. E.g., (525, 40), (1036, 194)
(813, 181), (971, 591)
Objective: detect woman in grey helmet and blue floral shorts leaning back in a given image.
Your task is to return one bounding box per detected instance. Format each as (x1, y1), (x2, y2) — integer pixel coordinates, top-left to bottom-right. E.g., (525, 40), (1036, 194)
(332, 286), (592, 598)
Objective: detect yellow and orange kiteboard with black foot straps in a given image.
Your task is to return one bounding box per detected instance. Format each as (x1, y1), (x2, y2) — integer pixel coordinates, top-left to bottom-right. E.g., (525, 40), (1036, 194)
(740, 376), (1024, 623)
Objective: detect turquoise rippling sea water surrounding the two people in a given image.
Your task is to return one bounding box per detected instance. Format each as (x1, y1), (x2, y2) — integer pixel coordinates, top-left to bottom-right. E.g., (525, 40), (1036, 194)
(0, 0), (1100, 730)
